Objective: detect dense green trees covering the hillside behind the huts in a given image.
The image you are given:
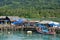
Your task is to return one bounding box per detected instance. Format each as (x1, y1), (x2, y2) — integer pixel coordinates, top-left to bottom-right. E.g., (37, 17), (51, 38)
(0, 0), (60, 18)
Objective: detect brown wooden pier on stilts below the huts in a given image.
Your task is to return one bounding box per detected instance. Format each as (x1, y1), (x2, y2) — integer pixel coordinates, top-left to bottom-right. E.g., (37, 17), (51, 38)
(0, 24), (36, 31)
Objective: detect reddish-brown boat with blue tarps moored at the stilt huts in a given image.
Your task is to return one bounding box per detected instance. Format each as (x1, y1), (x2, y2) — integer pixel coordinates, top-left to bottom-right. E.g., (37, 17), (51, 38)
(36, 23), (56, 34)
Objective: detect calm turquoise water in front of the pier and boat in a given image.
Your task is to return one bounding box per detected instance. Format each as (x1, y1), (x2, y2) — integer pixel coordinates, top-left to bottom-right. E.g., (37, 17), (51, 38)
(0, 32), (60, 40)
